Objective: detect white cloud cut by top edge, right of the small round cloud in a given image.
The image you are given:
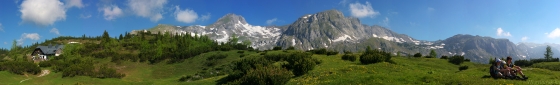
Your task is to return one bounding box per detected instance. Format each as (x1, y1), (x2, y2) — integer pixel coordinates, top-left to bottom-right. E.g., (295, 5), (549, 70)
(128, 0), (167, 22)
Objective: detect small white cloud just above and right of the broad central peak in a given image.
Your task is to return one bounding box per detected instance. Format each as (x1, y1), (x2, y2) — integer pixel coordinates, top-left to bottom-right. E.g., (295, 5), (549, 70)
(350, 1), (379, 18)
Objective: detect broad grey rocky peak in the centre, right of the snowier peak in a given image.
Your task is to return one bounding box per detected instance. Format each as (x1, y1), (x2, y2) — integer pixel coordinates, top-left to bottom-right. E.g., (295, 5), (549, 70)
(277, 10), (419, 50)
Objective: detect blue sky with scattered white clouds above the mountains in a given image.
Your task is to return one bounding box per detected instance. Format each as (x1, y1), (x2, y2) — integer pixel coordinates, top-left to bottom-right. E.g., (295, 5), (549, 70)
(0, 0), (560, 48)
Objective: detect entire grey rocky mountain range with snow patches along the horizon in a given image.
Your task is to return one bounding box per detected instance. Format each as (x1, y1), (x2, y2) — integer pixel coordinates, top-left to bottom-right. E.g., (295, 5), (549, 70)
(132, 10), (560, 63)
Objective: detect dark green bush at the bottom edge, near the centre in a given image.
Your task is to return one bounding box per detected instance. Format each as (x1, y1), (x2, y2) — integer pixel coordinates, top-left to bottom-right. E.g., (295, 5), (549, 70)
(229, 66), (294, 85)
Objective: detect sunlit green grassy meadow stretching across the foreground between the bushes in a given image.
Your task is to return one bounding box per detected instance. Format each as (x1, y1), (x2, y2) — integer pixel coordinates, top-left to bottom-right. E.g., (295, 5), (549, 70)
(4, 50), (560, 85)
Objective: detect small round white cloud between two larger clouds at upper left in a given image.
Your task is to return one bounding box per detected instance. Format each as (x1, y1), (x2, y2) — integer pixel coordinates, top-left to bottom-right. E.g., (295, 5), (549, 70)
(100, 5), (123, 20)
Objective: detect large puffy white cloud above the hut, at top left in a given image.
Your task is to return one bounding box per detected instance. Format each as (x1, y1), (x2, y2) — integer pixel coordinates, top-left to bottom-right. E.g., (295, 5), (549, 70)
(19, 0), (66, 26)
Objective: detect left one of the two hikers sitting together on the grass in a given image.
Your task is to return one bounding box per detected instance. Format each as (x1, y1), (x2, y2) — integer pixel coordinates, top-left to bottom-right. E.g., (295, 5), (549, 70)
(490, 58), (509, 78)
